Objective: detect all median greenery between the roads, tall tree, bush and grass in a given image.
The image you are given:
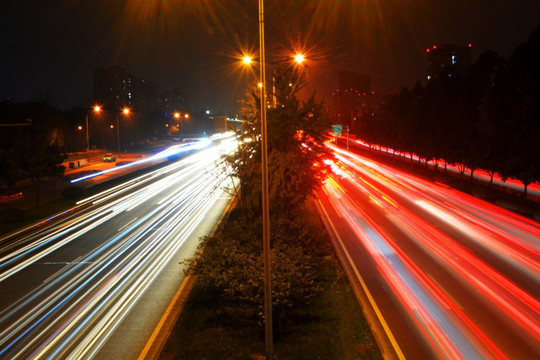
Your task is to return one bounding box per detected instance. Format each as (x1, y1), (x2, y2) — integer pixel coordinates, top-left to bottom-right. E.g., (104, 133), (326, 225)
(158, 64), (381, 359)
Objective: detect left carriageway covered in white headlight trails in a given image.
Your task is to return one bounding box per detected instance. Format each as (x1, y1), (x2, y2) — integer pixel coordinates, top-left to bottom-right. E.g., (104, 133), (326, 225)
(0, 136), (234, 359)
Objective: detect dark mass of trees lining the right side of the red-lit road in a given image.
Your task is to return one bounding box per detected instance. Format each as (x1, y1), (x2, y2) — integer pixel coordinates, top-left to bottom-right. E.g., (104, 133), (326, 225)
(359, 23), (540, 192)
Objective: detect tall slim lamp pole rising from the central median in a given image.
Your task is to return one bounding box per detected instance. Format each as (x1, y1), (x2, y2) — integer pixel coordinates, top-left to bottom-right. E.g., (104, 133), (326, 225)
(259, 0), (273, 360)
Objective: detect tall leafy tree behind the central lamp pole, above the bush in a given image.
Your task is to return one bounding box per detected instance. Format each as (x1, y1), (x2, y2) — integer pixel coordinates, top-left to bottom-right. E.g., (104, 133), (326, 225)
(227, 66), (331, 213)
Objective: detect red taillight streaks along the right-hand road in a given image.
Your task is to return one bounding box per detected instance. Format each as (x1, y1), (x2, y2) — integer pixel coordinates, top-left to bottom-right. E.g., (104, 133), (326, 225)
(318, 147), (540, 359)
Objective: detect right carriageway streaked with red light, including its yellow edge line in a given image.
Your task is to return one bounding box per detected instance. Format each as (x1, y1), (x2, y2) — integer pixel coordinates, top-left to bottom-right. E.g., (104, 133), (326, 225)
(317, 143), (540, 359)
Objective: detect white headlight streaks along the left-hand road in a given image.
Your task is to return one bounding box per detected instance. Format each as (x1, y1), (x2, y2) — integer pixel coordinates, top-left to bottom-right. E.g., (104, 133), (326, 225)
(0, 140), (238, 358)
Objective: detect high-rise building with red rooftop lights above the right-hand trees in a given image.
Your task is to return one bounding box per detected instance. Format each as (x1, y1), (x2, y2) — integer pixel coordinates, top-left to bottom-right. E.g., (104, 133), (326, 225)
(426, 44), (472, 81)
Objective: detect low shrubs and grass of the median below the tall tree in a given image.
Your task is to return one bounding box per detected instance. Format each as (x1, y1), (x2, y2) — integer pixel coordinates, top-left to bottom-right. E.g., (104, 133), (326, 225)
(160, 202), (382, 359)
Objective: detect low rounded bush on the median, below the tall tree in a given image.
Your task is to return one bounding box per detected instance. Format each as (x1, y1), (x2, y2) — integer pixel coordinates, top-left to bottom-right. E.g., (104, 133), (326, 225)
(181, 212), (322, 331)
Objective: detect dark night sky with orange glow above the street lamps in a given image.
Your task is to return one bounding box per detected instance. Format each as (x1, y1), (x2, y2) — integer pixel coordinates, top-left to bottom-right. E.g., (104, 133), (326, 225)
(0, 0), (540, 113)
